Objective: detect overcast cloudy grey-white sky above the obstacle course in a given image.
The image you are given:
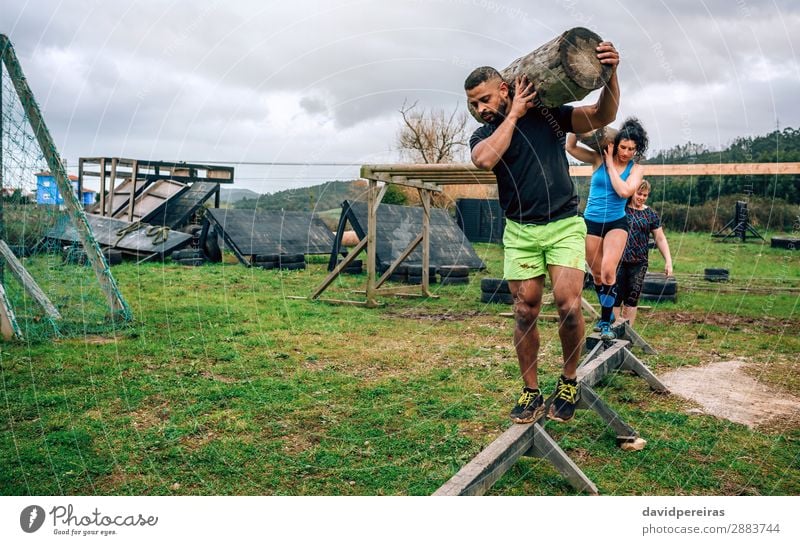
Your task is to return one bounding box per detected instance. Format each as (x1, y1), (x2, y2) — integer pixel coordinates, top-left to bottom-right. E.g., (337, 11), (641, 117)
(0, 0), (800, 192)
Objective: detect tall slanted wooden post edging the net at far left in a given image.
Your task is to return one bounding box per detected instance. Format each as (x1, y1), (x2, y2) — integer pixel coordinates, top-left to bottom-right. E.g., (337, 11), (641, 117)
(0, 34), (131, 320)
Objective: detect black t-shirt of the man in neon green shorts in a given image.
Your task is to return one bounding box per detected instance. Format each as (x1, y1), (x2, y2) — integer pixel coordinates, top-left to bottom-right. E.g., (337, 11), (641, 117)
(469, 106), (578, 224)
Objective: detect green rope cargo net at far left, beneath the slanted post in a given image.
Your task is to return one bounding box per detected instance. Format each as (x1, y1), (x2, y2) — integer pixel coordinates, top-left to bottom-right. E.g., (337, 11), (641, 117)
(0, 62), (119, 342)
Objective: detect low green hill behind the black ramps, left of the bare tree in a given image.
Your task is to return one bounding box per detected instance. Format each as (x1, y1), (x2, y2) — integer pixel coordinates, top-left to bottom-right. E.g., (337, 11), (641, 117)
(231, 180), (367, 212)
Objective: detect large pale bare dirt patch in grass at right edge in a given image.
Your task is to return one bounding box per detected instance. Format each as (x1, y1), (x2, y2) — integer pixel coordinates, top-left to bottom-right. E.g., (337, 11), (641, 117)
(660, 360), (800, 430)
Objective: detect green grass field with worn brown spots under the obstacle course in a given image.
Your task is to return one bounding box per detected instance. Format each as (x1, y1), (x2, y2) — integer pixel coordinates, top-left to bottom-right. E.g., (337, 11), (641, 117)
(0, 234), (800, 495)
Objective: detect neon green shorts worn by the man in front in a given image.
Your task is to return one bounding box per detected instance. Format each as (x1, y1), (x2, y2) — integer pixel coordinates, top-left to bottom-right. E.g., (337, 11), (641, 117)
(503, 216), (586, 280)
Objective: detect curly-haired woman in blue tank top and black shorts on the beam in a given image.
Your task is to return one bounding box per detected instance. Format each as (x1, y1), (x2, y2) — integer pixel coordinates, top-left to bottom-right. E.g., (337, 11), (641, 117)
(566, 117), (648, 340)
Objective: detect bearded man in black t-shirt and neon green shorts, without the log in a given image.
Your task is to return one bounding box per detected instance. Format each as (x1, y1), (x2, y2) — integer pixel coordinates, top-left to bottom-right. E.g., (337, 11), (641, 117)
(464, 42), (619, 423)
